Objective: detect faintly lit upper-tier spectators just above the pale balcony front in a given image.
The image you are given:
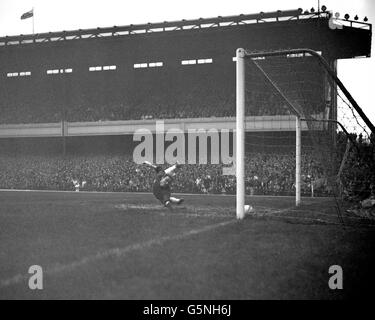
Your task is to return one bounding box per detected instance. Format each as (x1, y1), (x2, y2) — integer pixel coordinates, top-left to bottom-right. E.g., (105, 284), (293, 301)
(0, 95), (324, 124)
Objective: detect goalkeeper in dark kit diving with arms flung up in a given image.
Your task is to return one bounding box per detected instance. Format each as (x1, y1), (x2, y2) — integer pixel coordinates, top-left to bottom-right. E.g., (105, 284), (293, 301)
(143, 161), (184, 208)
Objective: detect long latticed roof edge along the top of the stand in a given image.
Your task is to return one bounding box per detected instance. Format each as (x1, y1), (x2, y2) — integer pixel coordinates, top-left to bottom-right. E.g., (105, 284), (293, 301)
(0, 9), (371, 46)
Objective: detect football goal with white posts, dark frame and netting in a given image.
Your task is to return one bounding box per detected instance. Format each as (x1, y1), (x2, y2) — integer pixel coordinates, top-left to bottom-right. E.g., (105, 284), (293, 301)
(236, 49), (375, 222)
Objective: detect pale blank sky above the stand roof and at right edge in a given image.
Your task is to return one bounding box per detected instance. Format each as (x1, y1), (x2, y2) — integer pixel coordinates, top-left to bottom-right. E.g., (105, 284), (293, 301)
(0, 0), (375, 123)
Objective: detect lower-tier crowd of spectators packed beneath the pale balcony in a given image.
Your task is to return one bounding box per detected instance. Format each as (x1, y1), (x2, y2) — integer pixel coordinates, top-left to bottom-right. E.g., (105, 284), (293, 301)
(0, 153), (334, 195)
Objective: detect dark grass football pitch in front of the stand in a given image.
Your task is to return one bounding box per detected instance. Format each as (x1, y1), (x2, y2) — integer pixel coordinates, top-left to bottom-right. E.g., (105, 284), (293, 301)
(0, 191), (375, 299)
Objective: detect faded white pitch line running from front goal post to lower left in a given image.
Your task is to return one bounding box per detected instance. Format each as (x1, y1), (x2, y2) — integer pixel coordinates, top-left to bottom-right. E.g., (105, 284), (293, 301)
(0, 220), (237, 288)
